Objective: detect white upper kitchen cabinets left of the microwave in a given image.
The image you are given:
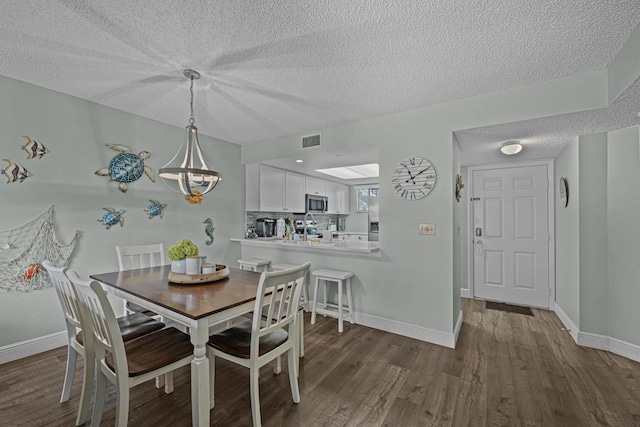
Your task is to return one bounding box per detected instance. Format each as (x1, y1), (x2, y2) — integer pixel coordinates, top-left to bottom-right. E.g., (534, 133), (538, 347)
(246, 165), (305, 212)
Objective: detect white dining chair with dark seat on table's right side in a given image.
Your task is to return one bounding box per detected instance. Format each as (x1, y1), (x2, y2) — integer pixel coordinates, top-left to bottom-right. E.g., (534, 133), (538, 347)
(207, 262), (311, 426)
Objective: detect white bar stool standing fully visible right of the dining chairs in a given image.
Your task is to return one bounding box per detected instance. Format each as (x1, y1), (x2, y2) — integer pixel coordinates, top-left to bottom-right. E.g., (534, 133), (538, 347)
(311, 269), (353, 332)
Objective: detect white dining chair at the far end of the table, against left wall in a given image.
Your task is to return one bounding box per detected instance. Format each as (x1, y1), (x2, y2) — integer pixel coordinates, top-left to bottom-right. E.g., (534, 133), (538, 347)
(116, 243), (167, 321)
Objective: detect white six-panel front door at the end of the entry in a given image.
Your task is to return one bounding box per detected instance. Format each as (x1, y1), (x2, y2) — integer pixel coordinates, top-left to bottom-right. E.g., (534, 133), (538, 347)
(470, 165), (550, 308)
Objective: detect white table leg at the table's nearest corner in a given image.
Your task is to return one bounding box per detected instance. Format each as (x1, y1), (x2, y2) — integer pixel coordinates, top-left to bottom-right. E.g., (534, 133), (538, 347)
(191, 319), (211, 427)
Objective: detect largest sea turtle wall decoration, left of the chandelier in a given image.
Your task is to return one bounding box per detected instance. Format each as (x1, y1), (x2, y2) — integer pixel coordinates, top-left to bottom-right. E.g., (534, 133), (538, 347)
(95, 144), (156, 193)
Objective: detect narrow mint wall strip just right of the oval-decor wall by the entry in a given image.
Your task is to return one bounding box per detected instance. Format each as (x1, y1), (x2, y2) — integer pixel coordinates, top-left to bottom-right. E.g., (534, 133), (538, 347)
(576, 133), (609, 335)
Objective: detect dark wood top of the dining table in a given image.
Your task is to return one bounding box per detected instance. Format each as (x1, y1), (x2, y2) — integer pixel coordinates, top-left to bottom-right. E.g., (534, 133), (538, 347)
(91, 265), (260, 319)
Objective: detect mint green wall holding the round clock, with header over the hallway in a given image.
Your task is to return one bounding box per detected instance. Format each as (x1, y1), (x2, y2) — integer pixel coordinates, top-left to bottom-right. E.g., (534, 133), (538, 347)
(242, 70), (607, 340)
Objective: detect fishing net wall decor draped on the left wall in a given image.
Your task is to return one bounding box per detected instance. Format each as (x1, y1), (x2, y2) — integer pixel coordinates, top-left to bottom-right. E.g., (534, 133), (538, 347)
(0, 205), (79, 292)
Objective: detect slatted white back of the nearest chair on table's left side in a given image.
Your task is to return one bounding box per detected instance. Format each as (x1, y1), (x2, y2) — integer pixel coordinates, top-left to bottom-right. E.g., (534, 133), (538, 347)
(67, 270), (129, 377)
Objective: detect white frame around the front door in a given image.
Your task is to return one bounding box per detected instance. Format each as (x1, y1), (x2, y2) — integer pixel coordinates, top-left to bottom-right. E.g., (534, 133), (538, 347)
(467, 159), (556, 310)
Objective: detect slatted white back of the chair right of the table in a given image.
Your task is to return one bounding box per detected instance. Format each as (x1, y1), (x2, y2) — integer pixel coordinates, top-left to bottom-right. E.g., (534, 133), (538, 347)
(251, 262), (311, 357)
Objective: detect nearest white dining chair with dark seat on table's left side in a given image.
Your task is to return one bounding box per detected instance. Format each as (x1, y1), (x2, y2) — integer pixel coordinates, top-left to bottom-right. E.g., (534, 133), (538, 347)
(69, 275), (193, 427)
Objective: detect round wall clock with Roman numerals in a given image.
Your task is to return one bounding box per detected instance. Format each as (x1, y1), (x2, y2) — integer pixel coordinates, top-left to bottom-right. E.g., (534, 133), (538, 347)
(391, 156), (438, 200)
